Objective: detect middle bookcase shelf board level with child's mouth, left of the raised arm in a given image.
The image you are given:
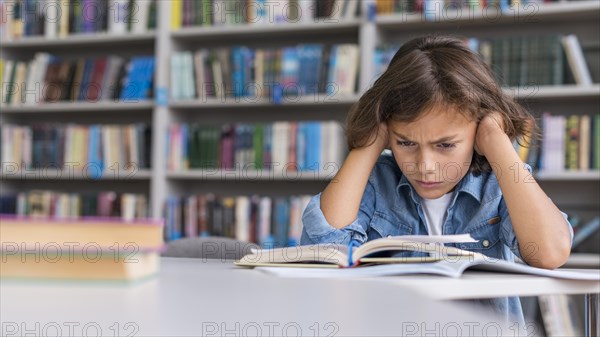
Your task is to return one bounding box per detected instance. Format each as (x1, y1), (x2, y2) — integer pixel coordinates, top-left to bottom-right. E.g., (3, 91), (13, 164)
(167, 169), (337, 182)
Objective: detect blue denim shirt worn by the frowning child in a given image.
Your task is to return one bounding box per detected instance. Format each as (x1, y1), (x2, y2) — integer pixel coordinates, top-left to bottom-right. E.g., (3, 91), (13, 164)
(301, 154), (573, 329)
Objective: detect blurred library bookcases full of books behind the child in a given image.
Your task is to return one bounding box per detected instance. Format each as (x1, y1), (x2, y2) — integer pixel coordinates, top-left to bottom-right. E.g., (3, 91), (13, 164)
(0, 0), (600, 335)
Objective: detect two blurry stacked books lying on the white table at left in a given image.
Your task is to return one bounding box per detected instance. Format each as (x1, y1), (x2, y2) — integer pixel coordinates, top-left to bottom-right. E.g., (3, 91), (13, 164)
(0, 215), (163, 281)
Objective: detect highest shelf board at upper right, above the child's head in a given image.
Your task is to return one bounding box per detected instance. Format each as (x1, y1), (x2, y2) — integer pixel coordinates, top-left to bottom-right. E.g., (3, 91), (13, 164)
(375, 0), (600, 30)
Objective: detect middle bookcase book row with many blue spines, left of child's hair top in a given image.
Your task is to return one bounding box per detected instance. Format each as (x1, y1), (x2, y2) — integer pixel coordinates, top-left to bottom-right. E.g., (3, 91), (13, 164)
(171, 44), (360, 103)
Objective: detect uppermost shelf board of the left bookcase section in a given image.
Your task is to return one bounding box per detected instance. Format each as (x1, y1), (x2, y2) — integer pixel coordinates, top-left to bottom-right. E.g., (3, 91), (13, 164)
(2, 31), (156, 49)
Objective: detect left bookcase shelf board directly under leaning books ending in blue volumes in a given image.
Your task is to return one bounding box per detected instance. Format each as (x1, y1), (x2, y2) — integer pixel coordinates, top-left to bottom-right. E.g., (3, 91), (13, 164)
(1, 101), (154, 114)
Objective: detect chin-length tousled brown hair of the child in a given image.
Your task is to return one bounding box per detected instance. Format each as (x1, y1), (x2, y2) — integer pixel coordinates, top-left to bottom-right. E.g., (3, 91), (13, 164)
(346, 35), (539, 175)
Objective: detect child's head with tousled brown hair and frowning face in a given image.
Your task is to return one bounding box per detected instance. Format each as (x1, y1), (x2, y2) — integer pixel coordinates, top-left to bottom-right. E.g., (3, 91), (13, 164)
(346, 35), (535, 192)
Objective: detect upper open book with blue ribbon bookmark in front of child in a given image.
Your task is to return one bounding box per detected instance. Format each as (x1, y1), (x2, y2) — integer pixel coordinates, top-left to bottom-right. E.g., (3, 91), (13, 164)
(235, 234), (477, 267)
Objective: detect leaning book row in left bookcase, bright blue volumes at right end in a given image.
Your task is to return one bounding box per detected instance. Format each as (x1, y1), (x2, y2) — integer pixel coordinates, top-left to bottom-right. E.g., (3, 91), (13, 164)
(0, 52), (155, 105)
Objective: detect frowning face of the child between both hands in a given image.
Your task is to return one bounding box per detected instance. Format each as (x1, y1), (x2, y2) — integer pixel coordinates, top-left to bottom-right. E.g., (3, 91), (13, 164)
(388, 109), (477, 199)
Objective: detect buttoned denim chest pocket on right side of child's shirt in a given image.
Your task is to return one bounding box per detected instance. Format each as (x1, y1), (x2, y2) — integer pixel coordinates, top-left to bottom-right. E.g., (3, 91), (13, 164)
(458, 215), (502, 258)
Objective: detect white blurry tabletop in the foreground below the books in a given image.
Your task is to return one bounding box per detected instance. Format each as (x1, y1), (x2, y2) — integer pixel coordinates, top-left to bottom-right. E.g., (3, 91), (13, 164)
(0, 258), (514, 336)
